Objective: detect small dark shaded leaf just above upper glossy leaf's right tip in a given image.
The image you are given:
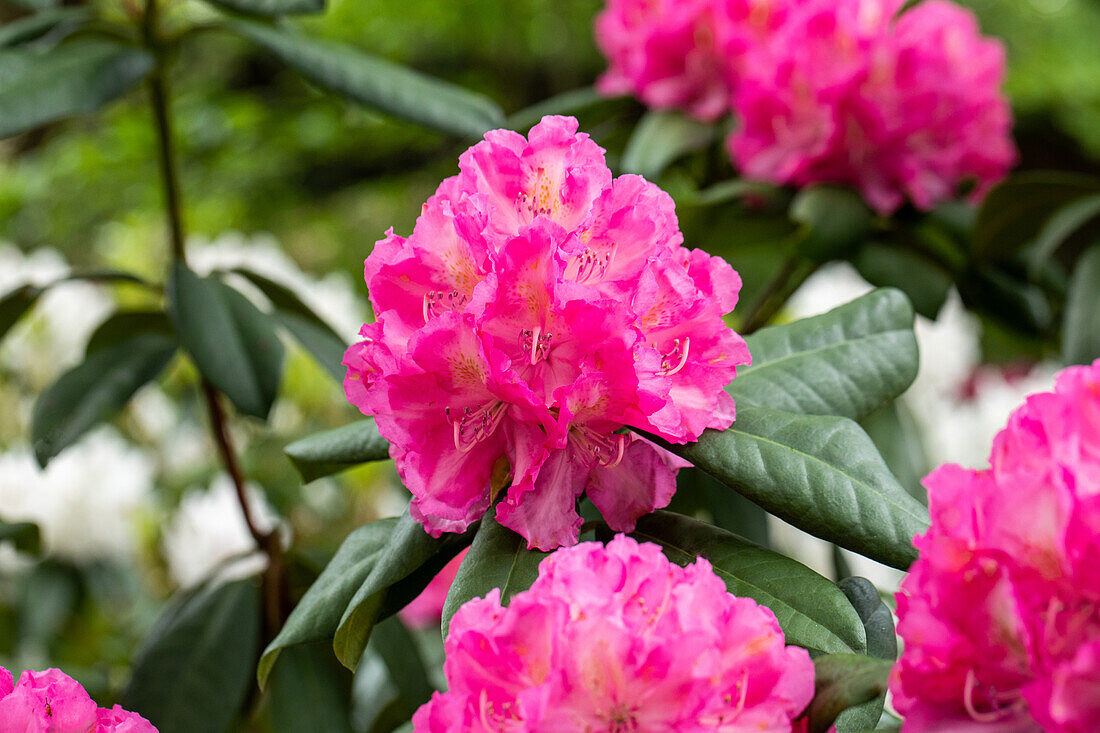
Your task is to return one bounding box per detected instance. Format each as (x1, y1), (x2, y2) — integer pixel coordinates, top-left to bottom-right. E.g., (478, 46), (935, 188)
(853, 242), (953, 320)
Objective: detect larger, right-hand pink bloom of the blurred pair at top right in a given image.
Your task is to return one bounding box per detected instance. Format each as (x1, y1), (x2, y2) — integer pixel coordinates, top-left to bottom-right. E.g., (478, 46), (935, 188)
(728, 0), (1016, 214)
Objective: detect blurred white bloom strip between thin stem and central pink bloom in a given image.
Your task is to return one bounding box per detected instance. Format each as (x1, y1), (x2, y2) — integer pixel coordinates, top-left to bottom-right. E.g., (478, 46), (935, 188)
(187, 232), (367, 342)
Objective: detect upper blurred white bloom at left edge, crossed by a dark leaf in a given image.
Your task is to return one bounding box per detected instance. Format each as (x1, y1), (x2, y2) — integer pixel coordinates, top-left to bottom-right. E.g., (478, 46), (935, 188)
(0, 244), (113, 387)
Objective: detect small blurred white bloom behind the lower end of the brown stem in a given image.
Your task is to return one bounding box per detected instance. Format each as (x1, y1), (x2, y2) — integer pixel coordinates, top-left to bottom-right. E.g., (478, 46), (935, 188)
(164, 474), (279, 588)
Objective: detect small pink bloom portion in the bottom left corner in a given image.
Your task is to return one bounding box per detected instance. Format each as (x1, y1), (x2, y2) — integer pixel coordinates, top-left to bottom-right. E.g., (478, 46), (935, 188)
(0, 667), (156, 733)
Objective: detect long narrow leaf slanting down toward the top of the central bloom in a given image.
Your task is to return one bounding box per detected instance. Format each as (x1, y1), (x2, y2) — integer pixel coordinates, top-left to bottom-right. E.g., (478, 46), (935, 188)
(232, 21), (504, 138)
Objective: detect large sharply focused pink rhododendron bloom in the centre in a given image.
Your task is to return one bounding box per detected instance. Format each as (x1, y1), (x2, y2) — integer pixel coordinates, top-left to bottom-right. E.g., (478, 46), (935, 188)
(344, 117), (749, 549)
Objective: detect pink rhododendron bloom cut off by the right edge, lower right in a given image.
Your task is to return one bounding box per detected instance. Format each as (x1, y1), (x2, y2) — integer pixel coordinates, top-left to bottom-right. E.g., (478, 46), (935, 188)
(891, 360), (1100, 733)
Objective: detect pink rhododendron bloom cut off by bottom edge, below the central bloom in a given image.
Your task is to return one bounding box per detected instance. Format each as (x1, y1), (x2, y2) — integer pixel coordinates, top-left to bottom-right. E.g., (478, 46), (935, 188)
(413, 535), (814, 733)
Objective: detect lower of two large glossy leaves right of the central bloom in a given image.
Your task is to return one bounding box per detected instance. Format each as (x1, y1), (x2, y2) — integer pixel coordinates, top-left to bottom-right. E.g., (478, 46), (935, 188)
(651, 405), (928, 570)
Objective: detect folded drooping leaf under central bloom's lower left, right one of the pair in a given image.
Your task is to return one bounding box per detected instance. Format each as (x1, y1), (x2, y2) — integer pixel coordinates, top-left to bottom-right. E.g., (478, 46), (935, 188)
(332, 511), (476, 669)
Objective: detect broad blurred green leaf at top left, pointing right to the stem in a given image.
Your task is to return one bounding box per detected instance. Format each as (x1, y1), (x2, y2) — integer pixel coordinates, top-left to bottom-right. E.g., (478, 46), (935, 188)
(0, 39), (153, 138)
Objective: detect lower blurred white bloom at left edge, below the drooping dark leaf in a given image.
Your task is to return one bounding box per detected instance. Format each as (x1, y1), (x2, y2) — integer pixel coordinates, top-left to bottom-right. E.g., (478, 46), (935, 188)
(0, 427), (153, 562)
